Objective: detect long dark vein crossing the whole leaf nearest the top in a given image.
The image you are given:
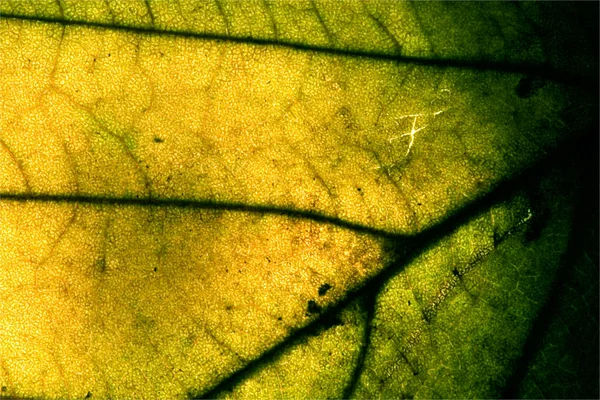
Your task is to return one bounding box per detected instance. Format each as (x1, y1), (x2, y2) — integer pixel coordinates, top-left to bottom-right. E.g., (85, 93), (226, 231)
(2, 14), (599, 92)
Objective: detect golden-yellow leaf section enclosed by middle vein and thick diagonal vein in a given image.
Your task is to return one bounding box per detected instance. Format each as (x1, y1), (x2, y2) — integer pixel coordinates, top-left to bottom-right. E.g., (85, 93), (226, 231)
(0, 203), (385, 398)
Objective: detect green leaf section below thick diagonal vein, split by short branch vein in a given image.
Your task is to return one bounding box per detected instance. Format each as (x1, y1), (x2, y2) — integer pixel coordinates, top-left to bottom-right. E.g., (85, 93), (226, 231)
(210, 162), (570, 398)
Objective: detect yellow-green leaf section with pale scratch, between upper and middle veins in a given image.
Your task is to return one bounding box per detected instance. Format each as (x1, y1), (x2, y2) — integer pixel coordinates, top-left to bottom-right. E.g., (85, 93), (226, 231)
(0, 16), (585, 233)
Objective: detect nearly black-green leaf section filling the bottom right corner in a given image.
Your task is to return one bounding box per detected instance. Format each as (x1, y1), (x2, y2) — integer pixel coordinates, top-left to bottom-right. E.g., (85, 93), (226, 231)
(503, 131), (600, 399)
